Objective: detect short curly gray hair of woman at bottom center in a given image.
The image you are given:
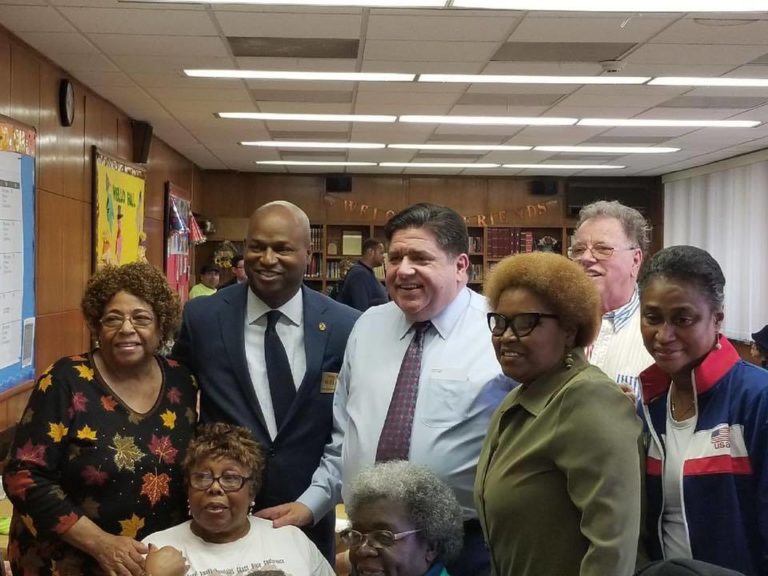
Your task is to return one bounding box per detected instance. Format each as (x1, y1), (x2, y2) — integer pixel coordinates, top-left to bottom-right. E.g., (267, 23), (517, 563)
(346, 460), (464, 563)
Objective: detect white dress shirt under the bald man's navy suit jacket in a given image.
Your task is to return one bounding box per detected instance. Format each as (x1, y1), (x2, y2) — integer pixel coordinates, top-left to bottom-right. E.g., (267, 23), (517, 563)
(245, 290), (307, 440)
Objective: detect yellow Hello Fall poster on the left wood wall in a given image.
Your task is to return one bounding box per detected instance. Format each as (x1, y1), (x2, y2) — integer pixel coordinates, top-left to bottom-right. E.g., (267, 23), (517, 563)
(93, 148), (147, 268)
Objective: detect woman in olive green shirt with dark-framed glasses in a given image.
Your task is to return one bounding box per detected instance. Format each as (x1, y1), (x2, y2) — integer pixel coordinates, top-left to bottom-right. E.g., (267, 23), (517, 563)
(475, 252), (641, 576)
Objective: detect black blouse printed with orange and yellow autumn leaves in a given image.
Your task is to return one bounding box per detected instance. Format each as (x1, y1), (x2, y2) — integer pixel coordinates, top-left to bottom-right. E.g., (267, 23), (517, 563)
(3, 354), (197, 576)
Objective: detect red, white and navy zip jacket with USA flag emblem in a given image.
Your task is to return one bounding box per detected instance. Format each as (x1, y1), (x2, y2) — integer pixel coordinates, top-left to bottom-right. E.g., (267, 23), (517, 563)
(640, 337), (768, 576)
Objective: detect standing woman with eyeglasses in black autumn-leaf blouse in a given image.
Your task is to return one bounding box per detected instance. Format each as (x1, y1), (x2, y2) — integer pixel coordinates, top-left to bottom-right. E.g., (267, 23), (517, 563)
(3, 263), (197, 576)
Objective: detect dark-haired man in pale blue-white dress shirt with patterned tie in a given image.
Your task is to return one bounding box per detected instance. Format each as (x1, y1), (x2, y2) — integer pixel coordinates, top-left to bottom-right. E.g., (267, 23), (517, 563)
(262, 204), (514, 576)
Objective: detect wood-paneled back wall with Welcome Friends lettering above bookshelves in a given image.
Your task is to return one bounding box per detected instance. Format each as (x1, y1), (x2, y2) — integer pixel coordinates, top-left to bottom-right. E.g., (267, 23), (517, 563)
(194, 171), (663, 235)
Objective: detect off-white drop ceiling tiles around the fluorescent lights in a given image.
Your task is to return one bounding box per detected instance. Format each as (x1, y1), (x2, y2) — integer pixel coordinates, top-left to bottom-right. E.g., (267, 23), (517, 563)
(0, 6), (768, 173)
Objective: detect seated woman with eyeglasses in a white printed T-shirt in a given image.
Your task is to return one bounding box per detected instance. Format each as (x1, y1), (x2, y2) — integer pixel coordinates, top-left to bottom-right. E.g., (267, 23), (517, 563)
(144, 423), (334, 576)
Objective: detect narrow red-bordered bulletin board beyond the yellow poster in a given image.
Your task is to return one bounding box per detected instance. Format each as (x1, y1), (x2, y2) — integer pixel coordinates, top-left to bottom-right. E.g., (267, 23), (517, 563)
(165, 182), (192, 304)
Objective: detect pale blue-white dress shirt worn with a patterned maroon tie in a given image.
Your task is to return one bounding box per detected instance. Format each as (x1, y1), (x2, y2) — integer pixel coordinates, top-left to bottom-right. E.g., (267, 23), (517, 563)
(299, 288), (515, 518)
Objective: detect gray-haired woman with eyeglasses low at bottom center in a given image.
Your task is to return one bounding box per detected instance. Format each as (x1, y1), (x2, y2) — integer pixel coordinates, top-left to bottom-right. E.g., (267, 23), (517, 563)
(341, 460), (464, 576)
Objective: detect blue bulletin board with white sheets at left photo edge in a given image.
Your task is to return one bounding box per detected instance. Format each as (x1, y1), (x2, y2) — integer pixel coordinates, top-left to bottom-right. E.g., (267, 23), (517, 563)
(0, 116), (36, 392)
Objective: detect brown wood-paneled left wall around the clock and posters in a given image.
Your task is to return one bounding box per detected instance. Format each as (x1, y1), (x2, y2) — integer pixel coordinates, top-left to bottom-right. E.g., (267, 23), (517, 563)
(0, 27), (199, 430)
